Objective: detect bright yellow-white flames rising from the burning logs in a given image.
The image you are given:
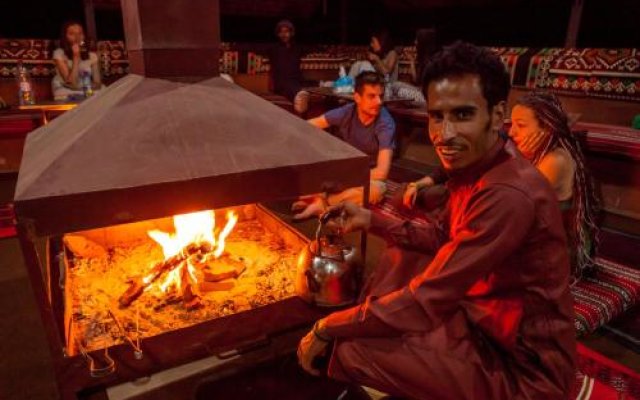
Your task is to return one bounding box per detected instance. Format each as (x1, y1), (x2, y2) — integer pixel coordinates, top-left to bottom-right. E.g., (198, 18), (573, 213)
(143, 210), (238, 293)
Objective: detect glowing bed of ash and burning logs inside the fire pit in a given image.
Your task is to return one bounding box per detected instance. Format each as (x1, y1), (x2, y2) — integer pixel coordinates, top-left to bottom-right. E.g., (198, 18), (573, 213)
(63, 205), (306, 355)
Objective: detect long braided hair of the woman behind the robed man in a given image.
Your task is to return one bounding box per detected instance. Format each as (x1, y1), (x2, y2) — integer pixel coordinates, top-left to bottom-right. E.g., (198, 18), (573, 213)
(516, 91), (600, 283)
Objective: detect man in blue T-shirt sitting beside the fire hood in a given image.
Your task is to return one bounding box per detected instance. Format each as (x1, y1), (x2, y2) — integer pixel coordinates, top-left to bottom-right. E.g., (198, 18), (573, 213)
(292, 71), (396, 219)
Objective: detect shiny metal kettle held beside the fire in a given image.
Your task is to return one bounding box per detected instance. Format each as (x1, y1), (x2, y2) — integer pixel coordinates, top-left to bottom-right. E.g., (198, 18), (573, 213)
(296, 213), (361, 307)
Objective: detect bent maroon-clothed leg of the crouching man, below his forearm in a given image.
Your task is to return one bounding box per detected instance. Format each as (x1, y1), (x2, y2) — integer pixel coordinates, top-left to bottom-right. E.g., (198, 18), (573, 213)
(328, 311), (516, 400)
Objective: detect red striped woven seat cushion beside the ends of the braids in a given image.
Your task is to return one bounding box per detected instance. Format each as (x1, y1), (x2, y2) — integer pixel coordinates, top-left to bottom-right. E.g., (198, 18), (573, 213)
(571, 257), (640, 336)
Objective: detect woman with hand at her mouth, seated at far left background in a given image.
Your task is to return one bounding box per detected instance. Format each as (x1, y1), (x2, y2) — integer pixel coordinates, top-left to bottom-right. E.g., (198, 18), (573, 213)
(51, 21), (102, 100)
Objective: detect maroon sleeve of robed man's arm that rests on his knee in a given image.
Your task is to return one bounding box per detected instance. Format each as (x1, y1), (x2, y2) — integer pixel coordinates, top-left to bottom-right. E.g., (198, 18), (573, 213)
(325, 185), (535, 337)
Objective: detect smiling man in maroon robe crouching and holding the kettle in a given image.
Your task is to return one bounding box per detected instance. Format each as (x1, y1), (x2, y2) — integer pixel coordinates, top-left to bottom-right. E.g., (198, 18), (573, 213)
(298, 42), (575, 400)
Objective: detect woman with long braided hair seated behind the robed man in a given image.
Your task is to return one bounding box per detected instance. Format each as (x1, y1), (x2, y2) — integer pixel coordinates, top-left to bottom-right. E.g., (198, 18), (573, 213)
(509, 91), (600, 281)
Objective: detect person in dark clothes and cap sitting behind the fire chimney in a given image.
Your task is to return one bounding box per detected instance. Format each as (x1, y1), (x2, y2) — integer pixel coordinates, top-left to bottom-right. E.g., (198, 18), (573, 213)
(269, 19), (309, 114)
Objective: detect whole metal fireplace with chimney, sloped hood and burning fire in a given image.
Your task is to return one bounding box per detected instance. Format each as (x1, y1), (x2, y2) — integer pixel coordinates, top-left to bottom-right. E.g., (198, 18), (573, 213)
(14, 0), (369, 398)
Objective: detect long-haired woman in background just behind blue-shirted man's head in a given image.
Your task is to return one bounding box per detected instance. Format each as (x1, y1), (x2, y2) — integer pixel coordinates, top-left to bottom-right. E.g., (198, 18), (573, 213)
(349, 30), (398, 83)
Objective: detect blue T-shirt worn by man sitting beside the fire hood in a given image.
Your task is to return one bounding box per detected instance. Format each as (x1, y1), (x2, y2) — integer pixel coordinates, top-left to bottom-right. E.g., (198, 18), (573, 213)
(324, 103), (396, 168)
